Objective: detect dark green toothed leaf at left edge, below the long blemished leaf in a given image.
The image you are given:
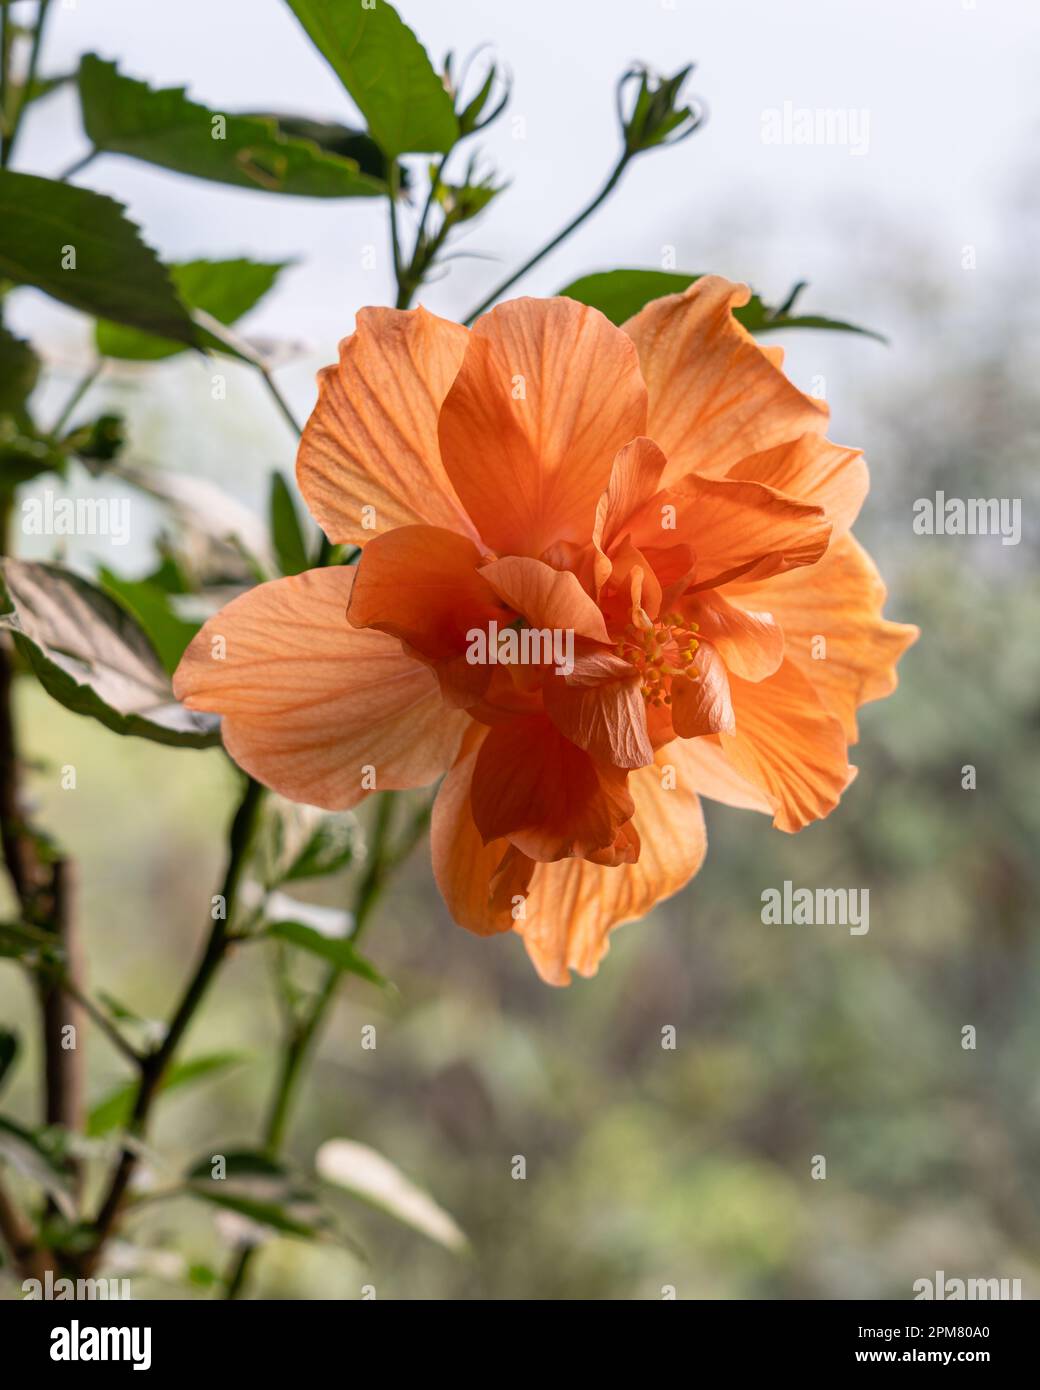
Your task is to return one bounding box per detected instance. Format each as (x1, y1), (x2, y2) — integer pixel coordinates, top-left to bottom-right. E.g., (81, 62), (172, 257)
(0, 170), (199, 345)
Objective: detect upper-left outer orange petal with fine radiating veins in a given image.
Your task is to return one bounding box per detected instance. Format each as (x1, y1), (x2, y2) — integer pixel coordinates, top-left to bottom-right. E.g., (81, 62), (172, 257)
(296, 309), (477, 545)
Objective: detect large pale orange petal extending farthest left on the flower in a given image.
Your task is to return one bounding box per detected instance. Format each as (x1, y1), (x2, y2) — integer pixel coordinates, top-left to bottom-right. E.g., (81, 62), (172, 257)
(174, 567), (470, 810)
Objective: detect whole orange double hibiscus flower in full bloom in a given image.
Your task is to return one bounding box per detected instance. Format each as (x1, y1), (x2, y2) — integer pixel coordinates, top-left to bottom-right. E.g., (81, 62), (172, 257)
(175, 277), (916, 984)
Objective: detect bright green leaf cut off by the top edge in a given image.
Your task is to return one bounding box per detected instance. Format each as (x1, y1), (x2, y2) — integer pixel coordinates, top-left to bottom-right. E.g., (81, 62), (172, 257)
(288, 0), (459, 158)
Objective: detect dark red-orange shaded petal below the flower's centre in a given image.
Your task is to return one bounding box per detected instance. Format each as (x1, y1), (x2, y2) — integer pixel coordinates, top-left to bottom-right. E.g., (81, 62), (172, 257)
(471, 714), (633, 860)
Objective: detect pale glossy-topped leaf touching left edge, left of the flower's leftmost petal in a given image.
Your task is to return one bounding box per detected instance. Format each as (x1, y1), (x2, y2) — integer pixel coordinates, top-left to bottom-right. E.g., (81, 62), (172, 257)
(0, 559), (220, 748)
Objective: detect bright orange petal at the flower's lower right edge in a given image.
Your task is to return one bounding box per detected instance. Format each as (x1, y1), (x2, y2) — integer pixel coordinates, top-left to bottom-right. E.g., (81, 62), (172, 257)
(719, 660), (852, 831)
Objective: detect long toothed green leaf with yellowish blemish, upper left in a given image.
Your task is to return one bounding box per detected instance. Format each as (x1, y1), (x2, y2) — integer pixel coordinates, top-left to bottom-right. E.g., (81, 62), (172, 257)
(79, 53), (387, 197)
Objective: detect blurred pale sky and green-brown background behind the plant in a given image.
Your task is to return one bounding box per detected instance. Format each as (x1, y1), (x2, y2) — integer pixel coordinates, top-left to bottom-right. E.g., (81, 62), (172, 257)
(0, 0), (1040, 1298)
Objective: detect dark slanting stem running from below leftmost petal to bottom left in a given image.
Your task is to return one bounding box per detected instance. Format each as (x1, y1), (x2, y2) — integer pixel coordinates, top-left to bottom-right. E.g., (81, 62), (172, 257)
(83, 777), (264, 1272)
